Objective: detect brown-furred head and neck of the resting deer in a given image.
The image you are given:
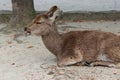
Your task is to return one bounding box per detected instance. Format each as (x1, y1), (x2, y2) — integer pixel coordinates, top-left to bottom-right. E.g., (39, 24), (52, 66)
(25, 6), (62, 56)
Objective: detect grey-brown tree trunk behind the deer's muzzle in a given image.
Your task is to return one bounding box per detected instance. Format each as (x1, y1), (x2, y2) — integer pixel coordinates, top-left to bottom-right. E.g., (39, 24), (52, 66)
(9, 0), (35, 28)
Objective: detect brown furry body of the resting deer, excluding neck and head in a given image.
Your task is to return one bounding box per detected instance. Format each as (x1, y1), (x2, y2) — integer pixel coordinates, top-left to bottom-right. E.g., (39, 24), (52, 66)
(58, 30), (120, 67)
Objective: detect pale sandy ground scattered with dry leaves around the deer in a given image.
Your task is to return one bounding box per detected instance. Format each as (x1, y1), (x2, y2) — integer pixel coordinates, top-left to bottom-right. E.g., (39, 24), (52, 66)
(0, 21), (120, 80)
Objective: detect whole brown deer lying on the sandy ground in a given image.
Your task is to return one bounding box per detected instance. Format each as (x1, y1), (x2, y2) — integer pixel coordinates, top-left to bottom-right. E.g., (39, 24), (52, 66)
(25, 6), (120, 68)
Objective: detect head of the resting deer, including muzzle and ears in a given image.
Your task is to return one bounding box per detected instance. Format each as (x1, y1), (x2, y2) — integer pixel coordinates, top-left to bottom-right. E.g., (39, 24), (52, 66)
(25, 6), (62, 35)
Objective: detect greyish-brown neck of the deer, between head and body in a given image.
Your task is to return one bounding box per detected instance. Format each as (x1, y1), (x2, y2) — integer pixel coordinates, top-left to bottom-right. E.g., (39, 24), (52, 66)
(42, 24), (62, 56)
